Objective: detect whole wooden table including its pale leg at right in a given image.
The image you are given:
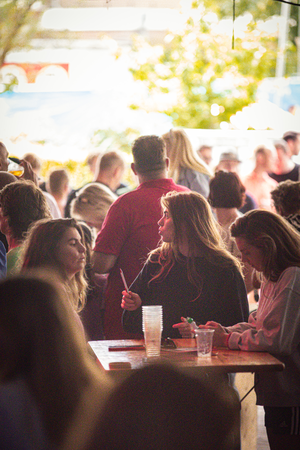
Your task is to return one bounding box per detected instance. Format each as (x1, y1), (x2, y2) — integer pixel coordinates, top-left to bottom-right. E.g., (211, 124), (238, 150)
(89, 339), (284, 450)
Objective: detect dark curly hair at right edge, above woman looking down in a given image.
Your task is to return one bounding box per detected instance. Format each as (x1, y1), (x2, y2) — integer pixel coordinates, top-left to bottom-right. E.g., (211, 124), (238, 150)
(271, 180), (300, 217)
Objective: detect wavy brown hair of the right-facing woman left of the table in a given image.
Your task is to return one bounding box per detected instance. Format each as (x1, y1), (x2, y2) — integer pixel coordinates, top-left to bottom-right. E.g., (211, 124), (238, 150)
(21, 219), (87, 311)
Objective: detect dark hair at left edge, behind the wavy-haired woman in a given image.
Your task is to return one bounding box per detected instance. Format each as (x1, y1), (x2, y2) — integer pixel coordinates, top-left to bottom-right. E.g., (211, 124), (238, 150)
(0, 180), (51, 242)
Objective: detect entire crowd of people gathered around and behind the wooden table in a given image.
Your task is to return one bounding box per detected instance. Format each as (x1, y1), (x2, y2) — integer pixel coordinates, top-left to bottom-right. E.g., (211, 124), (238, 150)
(0, 129), (300, 450)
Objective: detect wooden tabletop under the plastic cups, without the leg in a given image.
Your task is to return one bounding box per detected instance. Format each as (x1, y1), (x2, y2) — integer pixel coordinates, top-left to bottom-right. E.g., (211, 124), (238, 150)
(89, 339), (284, 375)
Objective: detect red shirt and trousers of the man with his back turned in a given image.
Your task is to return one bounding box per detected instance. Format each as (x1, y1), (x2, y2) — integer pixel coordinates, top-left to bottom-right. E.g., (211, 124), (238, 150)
(94, 178), (189, 339)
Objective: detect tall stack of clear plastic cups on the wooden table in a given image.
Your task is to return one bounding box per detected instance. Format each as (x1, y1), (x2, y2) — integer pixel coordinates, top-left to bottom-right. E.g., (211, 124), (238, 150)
(142, 305), (163, 358)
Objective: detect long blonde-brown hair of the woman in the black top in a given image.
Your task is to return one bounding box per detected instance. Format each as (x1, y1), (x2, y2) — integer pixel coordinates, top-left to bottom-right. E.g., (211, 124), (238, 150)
(148, 191), (241, 296)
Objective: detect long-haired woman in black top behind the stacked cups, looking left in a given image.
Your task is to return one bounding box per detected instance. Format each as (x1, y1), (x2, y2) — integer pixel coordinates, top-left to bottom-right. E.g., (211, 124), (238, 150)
(121, 192), (248, 338)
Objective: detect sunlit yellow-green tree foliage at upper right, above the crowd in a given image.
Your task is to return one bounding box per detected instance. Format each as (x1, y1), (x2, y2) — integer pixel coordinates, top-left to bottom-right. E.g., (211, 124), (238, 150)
(131, 0), (295, 128)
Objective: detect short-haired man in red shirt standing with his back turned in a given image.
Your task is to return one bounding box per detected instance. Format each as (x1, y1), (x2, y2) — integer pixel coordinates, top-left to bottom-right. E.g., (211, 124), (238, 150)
(92, 136), (188, 339)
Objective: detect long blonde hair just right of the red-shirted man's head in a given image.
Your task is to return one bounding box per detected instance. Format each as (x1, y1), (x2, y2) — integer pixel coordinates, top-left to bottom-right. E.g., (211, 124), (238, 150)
(162, 129), (212, 183)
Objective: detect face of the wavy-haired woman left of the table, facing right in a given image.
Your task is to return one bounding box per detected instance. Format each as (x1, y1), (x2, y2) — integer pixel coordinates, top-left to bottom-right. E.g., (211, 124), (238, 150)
(57, 227), (86, 278)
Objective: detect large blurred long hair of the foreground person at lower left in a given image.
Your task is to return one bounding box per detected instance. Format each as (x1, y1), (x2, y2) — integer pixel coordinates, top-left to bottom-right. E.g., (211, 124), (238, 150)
(0, 274), (96, 448)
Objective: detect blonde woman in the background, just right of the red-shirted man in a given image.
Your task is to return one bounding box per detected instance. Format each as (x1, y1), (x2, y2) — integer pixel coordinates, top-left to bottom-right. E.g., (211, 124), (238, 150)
(162, 129), (212, 198)
